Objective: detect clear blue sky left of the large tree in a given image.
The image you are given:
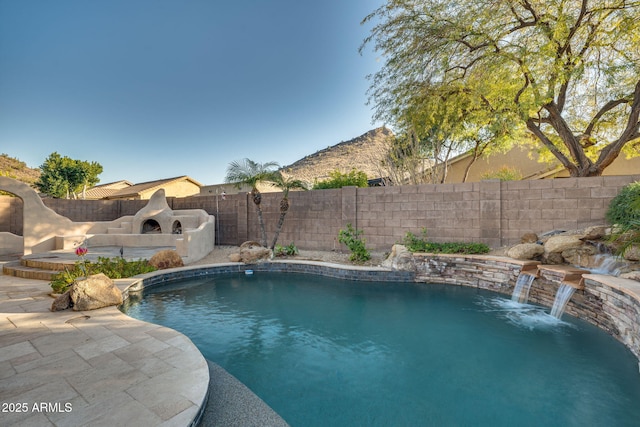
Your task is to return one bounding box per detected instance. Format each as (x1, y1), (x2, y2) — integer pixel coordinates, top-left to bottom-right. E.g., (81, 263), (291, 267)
(0, 0), (384, 184)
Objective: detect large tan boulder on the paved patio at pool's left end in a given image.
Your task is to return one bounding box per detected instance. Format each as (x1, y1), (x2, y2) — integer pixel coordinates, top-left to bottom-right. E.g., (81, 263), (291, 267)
(69, 273), (122, 311)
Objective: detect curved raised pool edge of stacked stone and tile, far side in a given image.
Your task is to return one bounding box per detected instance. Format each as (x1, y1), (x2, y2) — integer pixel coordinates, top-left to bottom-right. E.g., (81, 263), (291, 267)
(125, 253), (640, 359)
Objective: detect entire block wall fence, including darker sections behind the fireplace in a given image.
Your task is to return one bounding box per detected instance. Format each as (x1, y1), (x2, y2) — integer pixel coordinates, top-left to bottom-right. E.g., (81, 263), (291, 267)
(0, 176), (640, 250)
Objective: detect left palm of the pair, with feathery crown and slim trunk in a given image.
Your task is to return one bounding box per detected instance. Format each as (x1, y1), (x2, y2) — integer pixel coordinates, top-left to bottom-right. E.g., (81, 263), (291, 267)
(224, 159), (279, 247)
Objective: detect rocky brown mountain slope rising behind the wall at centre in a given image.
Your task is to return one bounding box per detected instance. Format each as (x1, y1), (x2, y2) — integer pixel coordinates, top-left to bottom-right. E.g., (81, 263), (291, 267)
(281, 127), (393, 184)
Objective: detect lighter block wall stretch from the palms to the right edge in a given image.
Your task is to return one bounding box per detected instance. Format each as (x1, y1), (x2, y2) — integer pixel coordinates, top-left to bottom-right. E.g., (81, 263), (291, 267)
(240, 175), (640, 250)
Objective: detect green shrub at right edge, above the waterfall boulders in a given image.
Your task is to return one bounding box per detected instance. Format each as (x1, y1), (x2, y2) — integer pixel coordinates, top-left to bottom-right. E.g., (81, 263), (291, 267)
(606, 181), (640, 255)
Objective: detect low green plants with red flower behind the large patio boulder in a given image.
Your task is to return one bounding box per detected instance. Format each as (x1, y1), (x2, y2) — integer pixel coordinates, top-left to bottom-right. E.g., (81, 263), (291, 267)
(50, 257), (156, 293)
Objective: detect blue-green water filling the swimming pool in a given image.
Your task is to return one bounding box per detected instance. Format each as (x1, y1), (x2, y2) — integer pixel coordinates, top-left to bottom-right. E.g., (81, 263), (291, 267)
(123, 272), (640, 427)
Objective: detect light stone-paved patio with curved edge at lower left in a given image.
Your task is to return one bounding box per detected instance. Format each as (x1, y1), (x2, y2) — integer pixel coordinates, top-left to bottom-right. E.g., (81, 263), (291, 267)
(0, 262), (209, 427)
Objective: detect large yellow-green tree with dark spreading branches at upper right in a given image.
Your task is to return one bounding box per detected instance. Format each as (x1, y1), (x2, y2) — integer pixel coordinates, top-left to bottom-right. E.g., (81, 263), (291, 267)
(361, 0), (640, 176)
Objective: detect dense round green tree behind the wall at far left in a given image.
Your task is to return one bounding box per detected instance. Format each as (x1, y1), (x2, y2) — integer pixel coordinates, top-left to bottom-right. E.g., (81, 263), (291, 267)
(35, 152), (102, 199)
